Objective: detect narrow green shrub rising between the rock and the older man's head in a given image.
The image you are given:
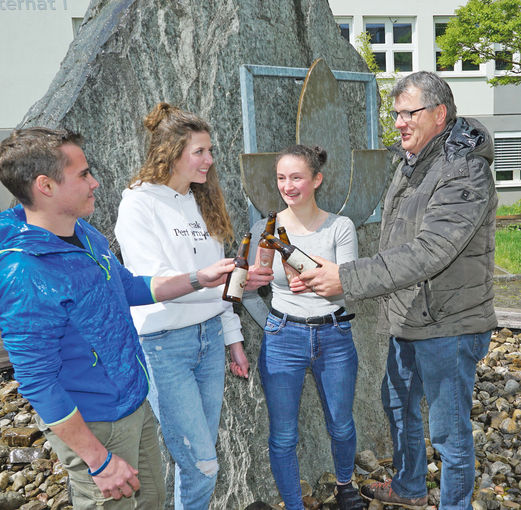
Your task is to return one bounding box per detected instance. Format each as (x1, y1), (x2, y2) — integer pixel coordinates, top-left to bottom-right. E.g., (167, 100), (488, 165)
(356, 32), (399, 147)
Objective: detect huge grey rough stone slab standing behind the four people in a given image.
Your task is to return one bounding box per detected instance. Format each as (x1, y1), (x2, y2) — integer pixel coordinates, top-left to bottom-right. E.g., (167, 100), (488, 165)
(22, 0), (390, 510)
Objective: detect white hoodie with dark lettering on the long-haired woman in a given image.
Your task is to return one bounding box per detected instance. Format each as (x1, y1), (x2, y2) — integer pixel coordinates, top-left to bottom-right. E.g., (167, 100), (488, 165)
(115, 183), (243, 345)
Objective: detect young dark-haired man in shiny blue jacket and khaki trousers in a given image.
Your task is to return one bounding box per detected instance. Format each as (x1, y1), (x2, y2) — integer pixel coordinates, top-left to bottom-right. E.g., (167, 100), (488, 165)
(0, 128), (238, 510)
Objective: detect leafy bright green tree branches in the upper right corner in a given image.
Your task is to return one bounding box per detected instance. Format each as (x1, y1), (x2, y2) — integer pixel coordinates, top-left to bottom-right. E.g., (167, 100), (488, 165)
(436, 0), (521, 86)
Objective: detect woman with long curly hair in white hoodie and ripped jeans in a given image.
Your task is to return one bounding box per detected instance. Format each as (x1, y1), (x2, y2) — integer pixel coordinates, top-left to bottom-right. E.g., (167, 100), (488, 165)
(116, 103), (271, 510)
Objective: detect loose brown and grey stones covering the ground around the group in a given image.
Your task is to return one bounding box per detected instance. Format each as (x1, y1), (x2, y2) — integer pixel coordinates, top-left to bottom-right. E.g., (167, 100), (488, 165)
(0, 329), (521, 510)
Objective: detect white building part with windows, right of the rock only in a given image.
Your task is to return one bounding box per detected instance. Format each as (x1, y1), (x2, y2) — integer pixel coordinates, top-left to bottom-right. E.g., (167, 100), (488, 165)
(329, 0), (521, 204)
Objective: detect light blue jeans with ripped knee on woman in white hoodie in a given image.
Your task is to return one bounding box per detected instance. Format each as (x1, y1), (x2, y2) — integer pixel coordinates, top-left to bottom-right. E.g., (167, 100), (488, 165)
(141, 317), (224, 510)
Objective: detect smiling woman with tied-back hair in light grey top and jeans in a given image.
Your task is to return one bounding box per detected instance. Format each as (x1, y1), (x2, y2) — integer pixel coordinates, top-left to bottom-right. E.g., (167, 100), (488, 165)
(250, 145), (364, 510)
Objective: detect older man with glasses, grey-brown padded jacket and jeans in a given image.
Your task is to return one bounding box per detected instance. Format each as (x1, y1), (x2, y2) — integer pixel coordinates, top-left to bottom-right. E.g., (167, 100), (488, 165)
(301, 72), (497, 510)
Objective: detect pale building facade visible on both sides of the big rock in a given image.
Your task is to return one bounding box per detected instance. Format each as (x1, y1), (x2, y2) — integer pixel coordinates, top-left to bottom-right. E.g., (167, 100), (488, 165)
(0, 0), (521, 210)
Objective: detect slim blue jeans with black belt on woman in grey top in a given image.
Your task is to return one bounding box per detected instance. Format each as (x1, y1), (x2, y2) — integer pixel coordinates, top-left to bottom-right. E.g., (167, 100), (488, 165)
(259, 314), (358, 510)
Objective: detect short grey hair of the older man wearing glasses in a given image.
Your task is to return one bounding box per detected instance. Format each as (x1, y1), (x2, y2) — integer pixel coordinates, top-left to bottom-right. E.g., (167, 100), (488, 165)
(391, 71), (457, 123)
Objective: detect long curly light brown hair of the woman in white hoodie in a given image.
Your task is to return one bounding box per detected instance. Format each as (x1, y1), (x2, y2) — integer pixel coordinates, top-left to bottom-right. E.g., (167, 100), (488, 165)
(129, 103), (234, 244)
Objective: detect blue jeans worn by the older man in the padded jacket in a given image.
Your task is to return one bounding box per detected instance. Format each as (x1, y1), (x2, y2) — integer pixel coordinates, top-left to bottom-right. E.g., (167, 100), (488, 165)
(382, 331), (491, 510)
